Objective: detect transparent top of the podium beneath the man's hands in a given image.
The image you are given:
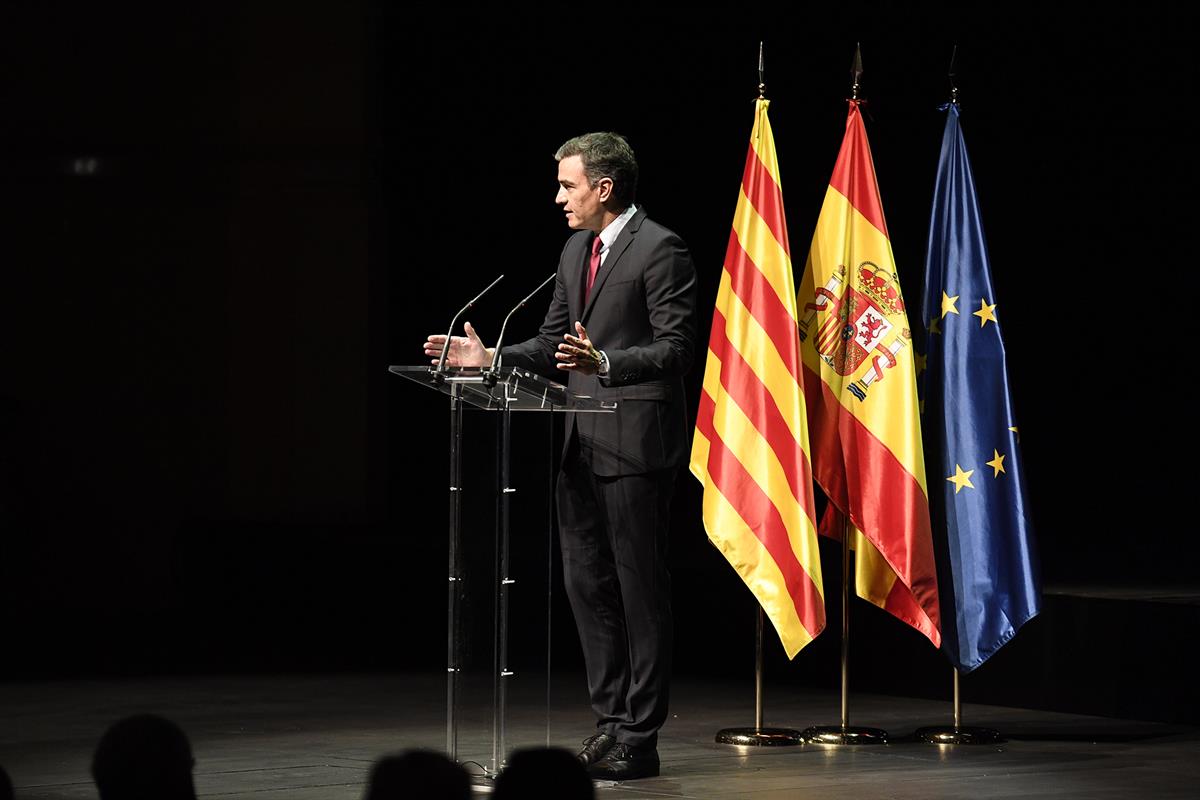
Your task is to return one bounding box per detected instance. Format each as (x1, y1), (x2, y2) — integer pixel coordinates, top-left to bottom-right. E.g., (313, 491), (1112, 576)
(388, 367), (617, 414)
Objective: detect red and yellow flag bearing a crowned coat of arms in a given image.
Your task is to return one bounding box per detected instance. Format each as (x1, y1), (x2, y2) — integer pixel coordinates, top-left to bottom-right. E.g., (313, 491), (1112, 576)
(798, 100), (941, 646)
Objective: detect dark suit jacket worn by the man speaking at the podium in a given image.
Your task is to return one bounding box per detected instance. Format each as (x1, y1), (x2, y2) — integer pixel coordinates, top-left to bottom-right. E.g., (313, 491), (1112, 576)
(500, 209), (696, 476)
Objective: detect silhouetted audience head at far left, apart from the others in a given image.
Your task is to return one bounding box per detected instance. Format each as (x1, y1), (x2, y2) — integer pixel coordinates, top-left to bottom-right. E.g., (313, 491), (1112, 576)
(91, 714), (196, 800)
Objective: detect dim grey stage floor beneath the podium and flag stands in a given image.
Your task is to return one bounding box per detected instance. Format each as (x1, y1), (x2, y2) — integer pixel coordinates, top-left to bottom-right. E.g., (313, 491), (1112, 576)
(0, 674), (1200, 800)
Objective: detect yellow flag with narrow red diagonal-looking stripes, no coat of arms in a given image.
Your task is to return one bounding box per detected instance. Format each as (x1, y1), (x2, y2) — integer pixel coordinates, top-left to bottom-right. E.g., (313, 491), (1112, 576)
(690, 100), (824, 658)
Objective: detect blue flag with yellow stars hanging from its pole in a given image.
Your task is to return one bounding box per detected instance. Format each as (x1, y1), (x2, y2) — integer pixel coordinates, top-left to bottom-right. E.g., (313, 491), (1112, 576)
(922, 103), (1042, 673)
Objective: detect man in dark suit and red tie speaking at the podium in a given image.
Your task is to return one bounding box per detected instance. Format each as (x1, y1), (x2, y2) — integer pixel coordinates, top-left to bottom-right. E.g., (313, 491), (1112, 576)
(425, 133), (696, 780)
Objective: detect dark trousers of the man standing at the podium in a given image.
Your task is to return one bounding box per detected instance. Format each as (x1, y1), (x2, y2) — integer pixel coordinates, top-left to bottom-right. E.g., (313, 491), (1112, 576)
(557, 437), (676, 746)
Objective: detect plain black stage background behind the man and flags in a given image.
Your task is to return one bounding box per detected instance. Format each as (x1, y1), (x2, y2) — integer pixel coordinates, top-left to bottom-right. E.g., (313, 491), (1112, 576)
(0, 1), (1198, 717)
